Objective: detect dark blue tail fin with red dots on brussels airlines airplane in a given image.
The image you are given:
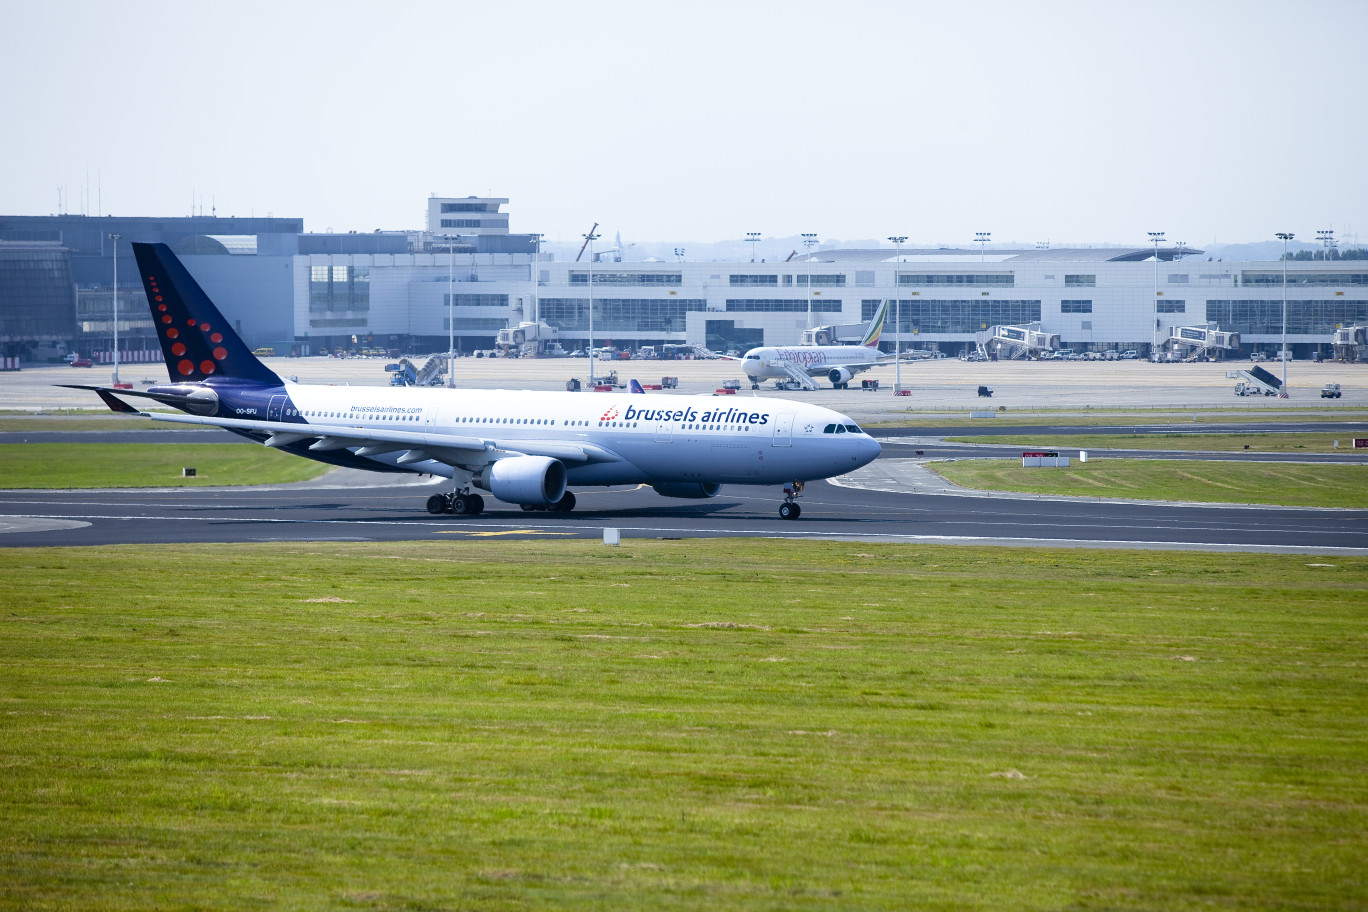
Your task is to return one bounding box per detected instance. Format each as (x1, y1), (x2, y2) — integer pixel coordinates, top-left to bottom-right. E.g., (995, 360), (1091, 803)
(133, 243), (280, 386)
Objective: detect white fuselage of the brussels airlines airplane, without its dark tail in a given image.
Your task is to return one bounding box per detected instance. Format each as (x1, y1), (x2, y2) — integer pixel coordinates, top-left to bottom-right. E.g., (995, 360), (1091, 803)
(272, 382), (880, 485)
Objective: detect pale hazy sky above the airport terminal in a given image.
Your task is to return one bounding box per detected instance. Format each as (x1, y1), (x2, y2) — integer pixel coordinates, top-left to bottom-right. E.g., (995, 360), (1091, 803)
(0, 0), (1368, 246)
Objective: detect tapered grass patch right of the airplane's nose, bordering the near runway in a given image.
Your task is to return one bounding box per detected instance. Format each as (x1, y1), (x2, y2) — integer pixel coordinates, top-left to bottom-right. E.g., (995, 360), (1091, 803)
(928, 454), (1368, 509)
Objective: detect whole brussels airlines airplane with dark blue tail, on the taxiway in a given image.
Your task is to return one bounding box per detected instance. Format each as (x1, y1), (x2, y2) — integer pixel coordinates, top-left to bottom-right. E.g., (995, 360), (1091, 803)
(63, 243), (880, 520)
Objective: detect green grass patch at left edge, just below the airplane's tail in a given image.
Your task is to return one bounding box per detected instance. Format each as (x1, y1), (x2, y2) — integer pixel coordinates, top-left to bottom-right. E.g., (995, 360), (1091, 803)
(0, 443), (330, 488)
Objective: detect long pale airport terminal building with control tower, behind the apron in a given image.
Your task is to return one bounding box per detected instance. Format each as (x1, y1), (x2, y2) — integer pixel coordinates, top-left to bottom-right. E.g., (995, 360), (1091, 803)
(0, 197), (1368, 358)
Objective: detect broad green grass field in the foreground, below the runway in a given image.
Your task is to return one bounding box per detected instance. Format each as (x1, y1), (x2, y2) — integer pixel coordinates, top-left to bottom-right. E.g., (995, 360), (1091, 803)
(0, 540), (1368, 909)
